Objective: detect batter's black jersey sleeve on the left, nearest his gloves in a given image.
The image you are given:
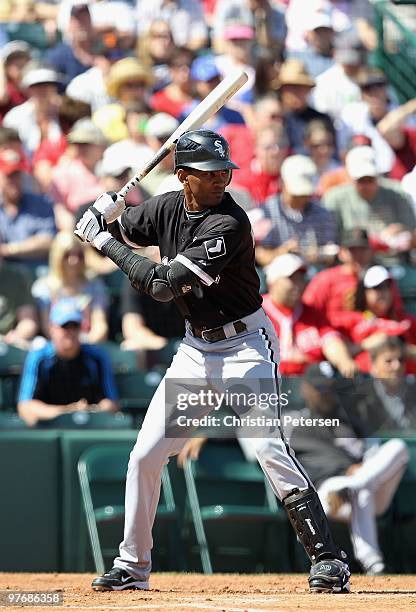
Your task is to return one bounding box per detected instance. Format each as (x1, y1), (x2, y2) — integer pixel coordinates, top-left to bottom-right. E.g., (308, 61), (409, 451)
(119, 198), (158, 247)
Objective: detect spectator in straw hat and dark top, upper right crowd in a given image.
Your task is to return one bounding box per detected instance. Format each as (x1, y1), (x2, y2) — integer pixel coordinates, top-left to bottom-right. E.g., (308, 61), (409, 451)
(279, 59), (335, 153)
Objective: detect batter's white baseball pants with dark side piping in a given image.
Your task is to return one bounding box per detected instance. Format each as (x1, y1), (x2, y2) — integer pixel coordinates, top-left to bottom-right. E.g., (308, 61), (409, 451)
(114, 309), (312, 582)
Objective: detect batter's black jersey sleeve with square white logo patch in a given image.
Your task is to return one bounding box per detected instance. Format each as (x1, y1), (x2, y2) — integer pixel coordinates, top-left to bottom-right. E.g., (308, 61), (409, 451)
(175, 218), (249, 286)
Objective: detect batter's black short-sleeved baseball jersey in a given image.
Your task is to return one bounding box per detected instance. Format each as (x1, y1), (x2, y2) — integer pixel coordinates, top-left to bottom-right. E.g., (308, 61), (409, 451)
(120, 191), (262, 329)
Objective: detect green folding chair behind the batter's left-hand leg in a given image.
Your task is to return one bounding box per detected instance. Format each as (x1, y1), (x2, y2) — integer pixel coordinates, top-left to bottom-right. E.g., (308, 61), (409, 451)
(78, 443), (178, 574)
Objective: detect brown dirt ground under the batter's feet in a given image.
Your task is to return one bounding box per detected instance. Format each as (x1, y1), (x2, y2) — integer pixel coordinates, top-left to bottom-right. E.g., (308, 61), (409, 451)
(0, 573), (416, 612)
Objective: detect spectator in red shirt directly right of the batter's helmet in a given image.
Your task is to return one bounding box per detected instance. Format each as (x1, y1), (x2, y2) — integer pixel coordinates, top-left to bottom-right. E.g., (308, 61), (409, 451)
(233, 125), (289, 206)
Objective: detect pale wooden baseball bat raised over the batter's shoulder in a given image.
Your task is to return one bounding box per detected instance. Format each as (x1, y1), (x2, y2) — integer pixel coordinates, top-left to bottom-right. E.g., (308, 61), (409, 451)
(118, 72), (248, 197)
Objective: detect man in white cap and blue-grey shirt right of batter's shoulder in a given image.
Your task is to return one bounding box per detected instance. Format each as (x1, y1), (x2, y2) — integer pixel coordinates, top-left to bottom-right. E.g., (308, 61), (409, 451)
(254, 155), (337, 265)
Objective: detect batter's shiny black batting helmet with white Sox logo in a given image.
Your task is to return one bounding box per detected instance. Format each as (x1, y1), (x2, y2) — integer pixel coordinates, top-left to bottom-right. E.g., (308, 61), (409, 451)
(175, 130), (239, 172)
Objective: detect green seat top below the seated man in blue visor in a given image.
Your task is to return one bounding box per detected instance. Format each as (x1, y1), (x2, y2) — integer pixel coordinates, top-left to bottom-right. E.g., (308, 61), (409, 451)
(38, 410), (134, 429)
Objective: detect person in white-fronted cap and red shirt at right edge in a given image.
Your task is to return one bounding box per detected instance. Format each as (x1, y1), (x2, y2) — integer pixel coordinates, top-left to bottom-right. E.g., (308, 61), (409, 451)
(336, 266), (416, 373)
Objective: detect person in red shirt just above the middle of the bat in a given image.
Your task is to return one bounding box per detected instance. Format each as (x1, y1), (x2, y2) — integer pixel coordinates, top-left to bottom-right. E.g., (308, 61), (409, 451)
(149, 47), (195, 119)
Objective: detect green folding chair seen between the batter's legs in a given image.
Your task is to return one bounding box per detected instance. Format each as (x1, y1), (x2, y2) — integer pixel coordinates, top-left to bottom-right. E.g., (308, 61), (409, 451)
(184, 440), (290, 574)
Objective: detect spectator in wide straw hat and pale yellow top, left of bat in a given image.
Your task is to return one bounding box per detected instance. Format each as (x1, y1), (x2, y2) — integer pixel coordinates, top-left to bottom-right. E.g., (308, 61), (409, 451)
(93, 57), (154, 142)
